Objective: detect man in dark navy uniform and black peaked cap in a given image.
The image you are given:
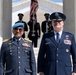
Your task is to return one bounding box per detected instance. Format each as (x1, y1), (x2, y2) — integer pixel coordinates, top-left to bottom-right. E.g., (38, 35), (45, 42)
(37, 12), (76, 75)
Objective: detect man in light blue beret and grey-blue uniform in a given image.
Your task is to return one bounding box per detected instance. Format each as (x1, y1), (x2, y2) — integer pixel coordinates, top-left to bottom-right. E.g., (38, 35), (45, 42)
(0, 23), (36, 75)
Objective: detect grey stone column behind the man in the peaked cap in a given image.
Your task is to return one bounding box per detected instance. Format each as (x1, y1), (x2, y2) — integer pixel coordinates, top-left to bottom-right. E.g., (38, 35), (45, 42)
(63, 0), (76, 38)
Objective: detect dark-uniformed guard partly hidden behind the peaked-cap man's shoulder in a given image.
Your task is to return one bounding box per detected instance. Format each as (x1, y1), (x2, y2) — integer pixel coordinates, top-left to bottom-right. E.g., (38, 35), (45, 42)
(41, 13), (51, 34)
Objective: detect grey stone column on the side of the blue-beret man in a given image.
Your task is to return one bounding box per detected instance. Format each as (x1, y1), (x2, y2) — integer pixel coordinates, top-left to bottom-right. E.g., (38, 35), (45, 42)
(0, 0), (12, 39)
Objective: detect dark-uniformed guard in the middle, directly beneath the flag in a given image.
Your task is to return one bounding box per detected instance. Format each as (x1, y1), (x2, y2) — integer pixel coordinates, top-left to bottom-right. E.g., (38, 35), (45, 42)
(28, 14), (40, 47)
